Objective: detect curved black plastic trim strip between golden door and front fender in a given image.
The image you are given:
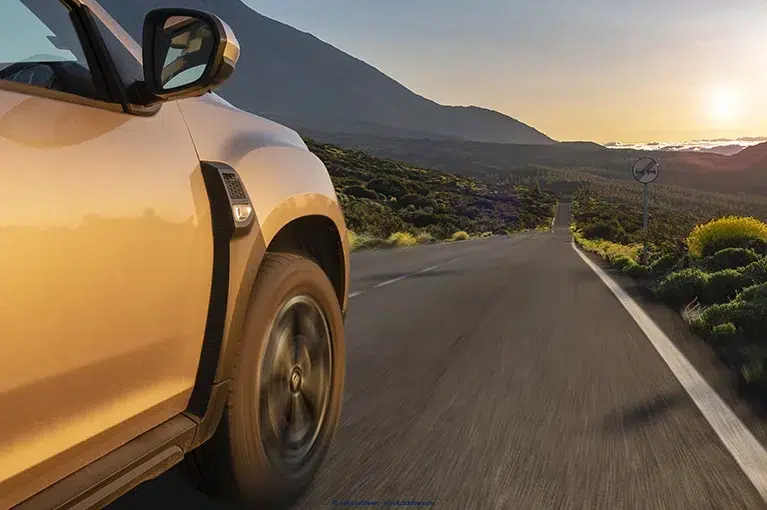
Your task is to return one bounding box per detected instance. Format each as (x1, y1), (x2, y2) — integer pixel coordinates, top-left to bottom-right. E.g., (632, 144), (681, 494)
(187, 161), (235, 420)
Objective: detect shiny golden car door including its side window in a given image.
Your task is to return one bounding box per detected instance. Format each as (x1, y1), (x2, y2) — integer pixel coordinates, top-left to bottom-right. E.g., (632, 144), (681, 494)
(0, 0), (213, 508)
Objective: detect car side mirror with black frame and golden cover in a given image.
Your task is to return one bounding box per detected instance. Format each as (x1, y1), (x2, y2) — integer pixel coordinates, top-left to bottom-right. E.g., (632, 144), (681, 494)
(143, 9), (240, 102)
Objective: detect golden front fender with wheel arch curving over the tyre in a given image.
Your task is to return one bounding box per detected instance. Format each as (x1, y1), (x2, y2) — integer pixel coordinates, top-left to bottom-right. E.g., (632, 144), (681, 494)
(178, 96), (350, 445)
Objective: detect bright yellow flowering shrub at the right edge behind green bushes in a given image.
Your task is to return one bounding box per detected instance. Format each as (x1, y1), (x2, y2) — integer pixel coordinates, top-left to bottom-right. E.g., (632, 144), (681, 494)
(685, 216), (767, 258)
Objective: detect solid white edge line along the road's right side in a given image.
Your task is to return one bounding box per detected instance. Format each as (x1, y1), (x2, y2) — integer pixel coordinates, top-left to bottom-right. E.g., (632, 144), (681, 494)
(572, 241), (767, 501)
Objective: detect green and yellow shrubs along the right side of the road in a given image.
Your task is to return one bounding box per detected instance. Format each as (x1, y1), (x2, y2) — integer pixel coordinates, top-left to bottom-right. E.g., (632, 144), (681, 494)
(571, 186), (767, 389)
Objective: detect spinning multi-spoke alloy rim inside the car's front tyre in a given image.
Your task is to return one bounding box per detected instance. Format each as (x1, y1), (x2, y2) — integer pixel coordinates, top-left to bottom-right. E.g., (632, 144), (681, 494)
(259, 295), (333, 469)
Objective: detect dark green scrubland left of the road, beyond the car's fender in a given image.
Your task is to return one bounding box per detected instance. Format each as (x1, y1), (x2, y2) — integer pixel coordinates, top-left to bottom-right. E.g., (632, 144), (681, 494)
(306, 140), (557, 250)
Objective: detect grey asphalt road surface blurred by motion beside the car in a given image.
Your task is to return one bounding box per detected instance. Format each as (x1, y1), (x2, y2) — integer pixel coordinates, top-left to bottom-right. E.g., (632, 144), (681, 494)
(110, 206), (765, 510)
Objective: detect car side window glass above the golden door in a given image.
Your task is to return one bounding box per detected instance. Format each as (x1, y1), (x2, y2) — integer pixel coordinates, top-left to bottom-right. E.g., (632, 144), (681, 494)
(0, 0), (101, 99)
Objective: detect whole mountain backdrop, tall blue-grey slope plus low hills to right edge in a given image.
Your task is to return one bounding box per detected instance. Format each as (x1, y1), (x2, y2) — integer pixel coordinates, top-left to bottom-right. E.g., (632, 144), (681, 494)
(99, 0), (767, 195)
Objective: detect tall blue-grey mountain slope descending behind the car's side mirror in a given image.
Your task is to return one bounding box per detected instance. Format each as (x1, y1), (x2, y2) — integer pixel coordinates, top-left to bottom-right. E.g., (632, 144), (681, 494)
(99, 0), (554, 145)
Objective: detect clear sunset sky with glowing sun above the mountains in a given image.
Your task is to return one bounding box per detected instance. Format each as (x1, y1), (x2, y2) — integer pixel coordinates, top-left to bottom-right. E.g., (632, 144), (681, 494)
(244, 0), (767, 142)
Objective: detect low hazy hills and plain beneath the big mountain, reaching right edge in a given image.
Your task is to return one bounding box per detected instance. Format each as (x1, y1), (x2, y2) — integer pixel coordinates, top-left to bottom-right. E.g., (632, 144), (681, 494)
(314, 133), (767, 196)
